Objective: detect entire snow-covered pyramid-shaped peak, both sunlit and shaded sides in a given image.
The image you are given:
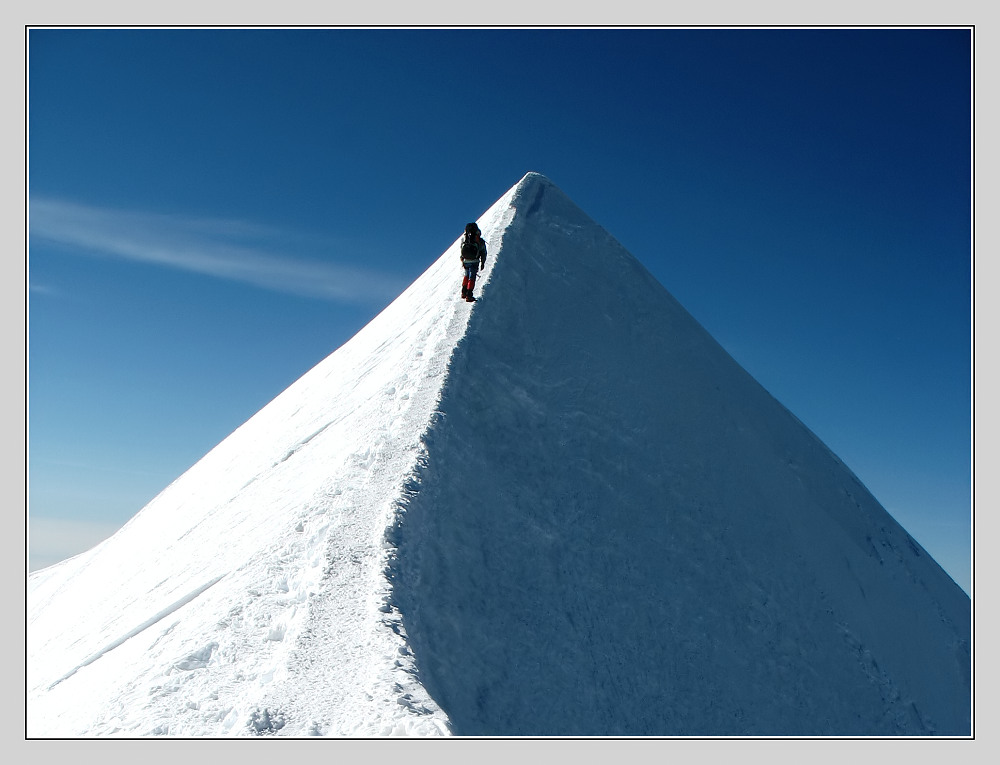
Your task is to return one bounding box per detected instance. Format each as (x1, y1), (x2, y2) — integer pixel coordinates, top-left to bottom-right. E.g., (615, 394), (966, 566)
(27, 174), (971, 737)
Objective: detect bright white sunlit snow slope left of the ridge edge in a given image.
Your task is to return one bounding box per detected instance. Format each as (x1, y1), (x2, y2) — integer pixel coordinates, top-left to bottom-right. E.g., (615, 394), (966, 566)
(27, 179), (512, 736)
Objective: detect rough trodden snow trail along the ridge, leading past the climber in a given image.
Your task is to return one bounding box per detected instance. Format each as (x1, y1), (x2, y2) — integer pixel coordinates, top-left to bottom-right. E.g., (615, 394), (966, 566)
(229, 176), (513, 736)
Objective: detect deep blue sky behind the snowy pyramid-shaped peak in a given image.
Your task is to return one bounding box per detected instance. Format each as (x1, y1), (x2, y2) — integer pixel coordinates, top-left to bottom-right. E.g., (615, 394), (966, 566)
(28, 29), (972, 590)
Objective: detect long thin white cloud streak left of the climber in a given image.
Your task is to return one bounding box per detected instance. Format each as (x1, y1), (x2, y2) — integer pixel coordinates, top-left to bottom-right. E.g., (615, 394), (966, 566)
(29, 198), (406, 304)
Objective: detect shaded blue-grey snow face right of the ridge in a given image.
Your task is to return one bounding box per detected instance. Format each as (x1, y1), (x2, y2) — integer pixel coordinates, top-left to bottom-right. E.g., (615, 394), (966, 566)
(386, 176), (971, 735)
